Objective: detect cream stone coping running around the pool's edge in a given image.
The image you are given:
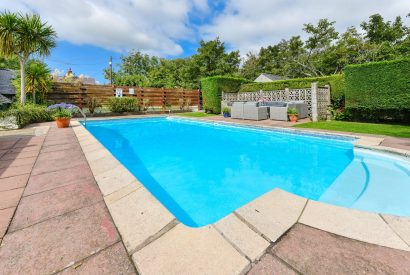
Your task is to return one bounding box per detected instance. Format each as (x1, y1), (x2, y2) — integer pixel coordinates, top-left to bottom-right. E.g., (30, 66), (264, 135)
(71, 120), (410, 274)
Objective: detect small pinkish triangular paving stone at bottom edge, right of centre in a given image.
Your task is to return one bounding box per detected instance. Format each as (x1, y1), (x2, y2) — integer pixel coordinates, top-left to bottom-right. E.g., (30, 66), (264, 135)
(248, 254), (298, 275)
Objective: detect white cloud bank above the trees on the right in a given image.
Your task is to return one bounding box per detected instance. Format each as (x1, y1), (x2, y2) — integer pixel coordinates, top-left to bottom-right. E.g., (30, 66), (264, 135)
(200, 0), (410, 55)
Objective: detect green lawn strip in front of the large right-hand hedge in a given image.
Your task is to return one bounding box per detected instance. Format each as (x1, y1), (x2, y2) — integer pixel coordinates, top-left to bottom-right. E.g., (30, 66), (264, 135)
(293, 121), (410, 138)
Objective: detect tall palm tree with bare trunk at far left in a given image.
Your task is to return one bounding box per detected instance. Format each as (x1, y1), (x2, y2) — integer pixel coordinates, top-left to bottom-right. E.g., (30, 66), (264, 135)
(0, 11), (57, 104)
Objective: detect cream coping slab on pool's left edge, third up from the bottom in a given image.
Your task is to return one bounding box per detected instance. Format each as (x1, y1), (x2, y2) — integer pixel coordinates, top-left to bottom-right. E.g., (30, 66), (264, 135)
(95, 165), (141, 196)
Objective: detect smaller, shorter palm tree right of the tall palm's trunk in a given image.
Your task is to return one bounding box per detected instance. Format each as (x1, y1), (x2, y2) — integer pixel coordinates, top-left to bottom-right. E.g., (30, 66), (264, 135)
(26, 60), (51, 104)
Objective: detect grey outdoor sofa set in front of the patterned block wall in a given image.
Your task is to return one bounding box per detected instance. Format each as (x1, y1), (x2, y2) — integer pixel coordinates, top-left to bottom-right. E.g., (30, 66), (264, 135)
(231, 101), (308, 121)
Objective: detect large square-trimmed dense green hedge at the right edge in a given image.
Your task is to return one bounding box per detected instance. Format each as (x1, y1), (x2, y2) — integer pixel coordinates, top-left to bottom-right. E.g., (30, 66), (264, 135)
(345, 59), (410, 122)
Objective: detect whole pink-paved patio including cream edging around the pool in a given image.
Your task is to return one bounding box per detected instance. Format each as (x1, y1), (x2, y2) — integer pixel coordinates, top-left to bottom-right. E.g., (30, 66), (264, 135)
(0, 118), (410, 274)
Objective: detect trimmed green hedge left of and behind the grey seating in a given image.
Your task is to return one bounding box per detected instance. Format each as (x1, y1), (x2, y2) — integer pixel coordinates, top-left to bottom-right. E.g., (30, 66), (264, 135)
(201, 76), (249, 114)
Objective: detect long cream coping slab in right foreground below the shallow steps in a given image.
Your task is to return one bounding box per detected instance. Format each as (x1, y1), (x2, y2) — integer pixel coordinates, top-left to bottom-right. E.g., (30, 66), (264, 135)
(299, 201), (410, 250)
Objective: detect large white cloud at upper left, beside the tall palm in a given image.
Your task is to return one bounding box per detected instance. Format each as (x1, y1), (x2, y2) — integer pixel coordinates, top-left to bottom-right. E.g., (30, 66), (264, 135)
(2, 0), (208, 55)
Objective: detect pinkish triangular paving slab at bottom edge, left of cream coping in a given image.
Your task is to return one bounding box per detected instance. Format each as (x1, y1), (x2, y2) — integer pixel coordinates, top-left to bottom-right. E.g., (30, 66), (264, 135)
(59, 242), (136, 275)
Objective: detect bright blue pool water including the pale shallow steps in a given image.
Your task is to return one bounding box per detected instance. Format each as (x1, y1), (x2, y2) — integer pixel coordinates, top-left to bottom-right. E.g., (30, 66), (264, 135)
(87, 118), (410, 227)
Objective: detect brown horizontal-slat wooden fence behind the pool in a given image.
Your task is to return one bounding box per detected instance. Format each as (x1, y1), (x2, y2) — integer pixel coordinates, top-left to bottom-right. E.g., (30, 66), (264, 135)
(47, 82), (200, 109)
